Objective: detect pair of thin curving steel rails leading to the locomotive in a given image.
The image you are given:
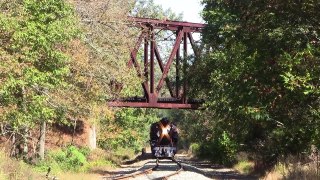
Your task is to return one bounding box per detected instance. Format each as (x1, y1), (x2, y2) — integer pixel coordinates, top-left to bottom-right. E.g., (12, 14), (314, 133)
(102, 158), (183, 180)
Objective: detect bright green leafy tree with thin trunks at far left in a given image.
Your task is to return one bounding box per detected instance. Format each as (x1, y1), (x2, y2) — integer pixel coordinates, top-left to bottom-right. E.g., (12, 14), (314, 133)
(0, 0), (78, 158)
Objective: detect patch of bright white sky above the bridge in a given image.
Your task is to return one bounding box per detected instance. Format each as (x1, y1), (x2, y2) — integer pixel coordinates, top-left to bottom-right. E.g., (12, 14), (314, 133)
(154, 0), (204, 23)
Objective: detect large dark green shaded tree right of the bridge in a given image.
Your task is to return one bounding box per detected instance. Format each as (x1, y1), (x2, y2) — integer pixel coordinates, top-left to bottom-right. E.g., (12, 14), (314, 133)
(194, 0), (320, 166)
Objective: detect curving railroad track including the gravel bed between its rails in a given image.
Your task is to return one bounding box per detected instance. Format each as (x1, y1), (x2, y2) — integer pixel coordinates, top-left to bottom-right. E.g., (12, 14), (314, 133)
(102, 159), (183, 180)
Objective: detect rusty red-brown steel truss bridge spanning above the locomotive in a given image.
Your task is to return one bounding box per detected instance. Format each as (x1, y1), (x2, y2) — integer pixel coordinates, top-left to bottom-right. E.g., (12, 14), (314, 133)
(109, 17), (205, 109)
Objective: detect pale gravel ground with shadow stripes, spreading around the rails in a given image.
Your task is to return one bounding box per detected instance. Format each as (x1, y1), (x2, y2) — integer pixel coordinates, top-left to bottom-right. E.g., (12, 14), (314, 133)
(101, 154), (256, 180)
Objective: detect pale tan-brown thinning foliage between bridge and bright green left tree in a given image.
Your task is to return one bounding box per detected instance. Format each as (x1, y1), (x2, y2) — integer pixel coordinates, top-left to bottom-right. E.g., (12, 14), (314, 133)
(73, 0), (142, 101)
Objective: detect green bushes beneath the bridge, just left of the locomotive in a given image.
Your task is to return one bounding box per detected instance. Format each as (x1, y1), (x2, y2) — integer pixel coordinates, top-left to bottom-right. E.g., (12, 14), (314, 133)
(98, 109), (159, 152)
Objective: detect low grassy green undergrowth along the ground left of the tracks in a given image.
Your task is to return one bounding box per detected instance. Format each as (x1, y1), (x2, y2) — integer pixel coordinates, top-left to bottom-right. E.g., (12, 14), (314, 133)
(0, 145), (139, 180)
